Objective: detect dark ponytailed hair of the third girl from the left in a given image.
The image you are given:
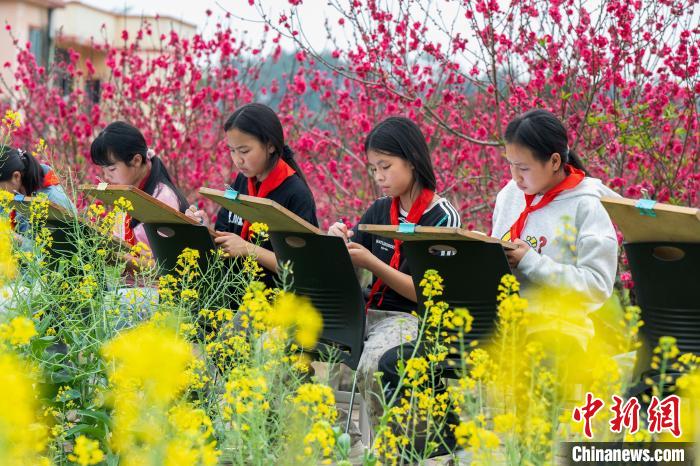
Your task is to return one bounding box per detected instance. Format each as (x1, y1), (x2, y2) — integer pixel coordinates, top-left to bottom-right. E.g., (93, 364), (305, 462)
(224, 103), (309, 186)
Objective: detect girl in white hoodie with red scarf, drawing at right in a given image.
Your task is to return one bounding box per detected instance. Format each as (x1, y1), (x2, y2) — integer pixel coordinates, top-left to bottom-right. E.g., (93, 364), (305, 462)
(492, 109), (618, 347)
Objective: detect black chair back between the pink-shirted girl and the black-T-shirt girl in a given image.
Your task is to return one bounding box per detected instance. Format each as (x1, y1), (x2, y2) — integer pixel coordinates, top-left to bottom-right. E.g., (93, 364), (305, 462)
(143, 223), (216, 275)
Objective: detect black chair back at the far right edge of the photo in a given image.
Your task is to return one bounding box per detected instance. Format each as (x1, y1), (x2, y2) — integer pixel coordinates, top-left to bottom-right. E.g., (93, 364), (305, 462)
(625, 242), (700, 354)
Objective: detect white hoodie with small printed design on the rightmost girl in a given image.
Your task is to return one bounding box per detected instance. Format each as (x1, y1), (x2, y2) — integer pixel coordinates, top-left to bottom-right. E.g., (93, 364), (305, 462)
(492, 177), (619, 347)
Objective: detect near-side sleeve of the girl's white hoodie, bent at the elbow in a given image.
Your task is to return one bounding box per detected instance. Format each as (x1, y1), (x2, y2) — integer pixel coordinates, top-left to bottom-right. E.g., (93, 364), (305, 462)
(517, 201), (617, 305)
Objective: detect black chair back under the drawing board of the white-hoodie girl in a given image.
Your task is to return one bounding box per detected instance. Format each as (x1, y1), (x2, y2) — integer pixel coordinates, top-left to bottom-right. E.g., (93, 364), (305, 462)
(403, 240), (511, 341)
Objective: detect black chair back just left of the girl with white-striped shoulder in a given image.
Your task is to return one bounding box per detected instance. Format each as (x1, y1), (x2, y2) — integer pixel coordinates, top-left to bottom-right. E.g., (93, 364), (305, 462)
(270, 231), (365, 369)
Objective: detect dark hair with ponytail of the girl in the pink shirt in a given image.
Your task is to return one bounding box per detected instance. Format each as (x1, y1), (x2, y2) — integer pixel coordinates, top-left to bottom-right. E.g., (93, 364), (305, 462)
(90, 121), (188, 212)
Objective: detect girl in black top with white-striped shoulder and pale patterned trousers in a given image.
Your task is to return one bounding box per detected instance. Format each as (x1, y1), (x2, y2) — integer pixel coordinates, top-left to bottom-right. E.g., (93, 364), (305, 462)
(328, 117), (460, 423)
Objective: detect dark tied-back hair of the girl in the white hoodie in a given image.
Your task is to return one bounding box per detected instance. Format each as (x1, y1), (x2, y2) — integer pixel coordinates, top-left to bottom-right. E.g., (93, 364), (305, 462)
(505, 108), (588, 175)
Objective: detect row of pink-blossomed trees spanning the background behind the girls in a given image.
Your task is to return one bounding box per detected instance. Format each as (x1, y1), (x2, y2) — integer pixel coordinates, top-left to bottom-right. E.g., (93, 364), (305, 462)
(1, 0), (700, 230)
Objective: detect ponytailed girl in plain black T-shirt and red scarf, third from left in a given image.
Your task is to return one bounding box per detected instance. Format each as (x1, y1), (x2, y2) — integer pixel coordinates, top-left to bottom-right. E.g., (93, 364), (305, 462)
(185, 103), (318, 285)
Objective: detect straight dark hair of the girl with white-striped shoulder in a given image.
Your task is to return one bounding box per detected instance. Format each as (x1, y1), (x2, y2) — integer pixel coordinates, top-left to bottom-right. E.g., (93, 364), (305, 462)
(365, 117), (437, 191)
